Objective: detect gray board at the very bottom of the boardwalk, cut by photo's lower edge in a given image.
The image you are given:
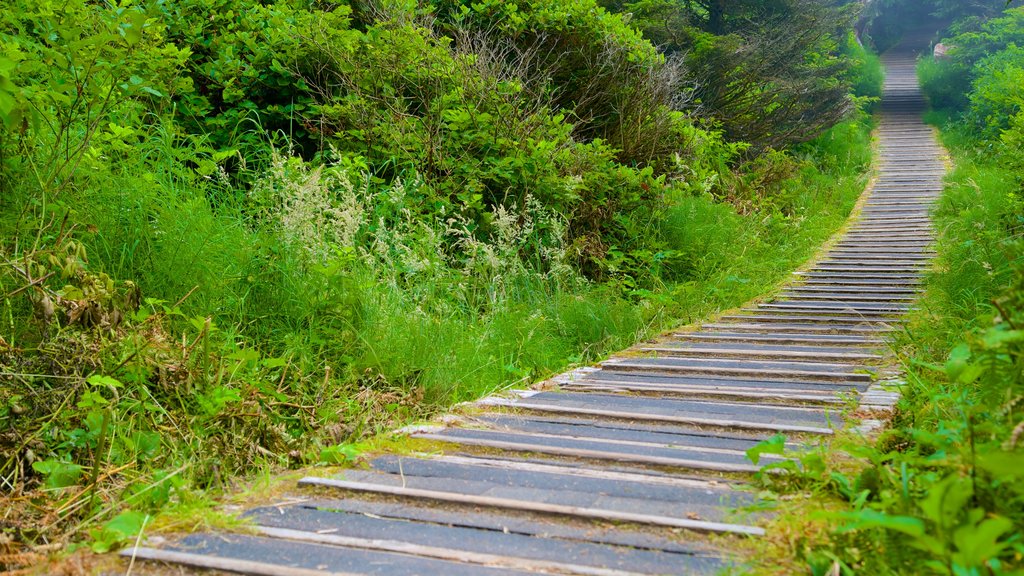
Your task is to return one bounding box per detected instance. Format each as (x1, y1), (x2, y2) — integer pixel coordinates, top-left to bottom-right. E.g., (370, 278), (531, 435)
(166, 534), (528, 576)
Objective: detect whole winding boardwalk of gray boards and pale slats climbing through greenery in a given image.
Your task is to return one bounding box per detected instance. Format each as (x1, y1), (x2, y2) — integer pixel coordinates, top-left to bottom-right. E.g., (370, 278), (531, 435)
(124, 38), (945, 576)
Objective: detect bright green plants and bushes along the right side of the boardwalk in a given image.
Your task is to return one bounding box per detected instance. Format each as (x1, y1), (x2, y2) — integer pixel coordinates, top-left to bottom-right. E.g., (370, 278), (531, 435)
(753, 4), (1024, 575)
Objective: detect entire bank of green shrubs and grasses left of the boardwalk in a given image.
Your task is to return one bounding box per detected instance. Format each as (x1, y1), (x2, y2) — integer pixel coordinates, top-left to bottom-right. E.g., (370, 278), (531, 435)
(0, 0), (881, 552)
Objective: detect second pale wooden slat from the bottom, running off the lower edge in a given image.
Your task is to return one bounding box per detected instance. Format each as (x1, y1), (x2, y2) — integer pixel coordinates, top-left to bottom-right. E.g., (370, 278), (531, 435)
(256, 526), (639, 576)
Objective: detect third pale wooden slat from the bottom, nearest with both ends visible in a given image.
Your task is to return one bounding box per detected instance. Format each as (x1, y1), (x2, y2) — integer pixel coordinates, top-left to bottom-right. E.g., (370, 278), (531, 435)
(299, 477), (765, 536)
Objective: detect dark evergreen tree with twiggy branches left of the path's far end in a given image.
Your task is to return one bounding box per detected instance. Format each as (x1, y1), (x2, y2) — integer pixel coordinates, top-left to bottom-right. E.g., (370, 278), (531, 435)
(604, 0), (878, 151)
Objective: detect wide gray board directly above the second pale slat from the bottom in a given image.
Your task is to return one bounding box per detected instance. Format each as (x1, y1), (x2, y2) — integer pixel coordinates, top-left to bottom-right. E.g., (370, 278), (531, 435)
(239, 500), (721, 574)
